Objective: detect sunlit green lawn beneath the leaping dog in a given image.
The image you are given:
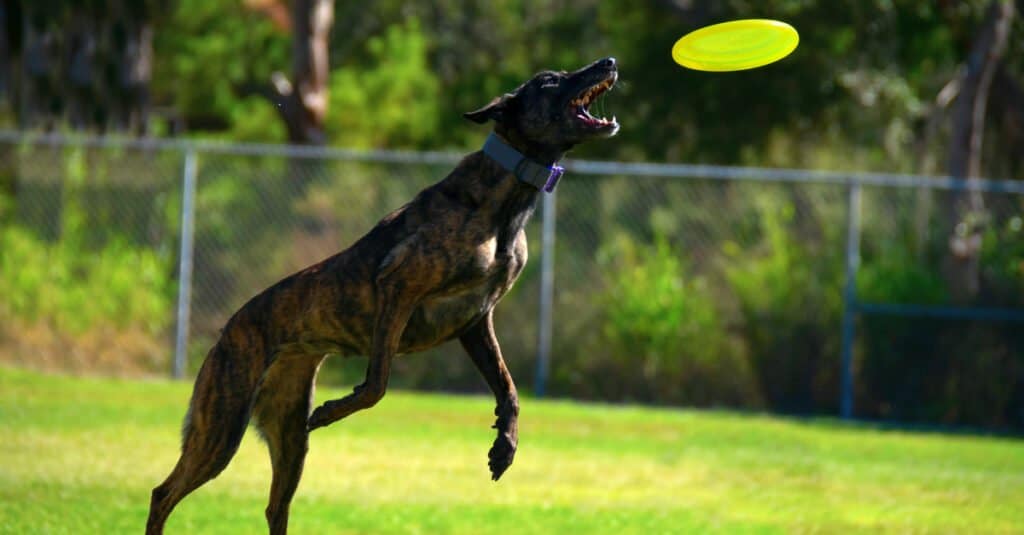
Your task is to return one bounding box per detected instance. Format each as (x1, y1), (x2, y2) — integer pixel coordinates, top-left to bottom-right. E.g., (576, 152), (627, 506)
(0, 368), (1024, 534)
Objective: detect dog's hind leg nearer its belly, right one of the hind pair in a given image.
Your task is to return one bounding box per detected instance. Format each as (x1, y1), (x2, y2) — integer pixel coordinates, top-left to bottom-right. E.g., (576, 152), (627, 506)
(253, 353), (324, 535)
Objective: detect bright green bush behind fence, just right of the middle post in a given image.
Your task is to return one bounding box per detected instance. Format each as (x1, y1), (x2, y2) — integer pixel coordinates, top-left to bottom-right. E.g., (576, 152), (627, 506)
(595, 235), (759, 406)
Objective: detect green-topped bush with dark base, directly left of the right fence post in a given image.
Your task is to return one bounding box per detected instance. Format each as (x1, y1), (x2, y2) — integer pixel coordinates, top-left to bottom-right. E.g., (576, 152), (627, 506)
(725, 197), (844, 412)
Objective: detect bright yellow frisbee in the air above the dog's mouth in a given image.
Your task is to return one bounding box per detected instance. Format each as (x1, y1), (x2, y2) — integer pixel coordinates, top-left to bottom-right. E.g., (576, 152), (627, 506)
(672, 18), (800, 72)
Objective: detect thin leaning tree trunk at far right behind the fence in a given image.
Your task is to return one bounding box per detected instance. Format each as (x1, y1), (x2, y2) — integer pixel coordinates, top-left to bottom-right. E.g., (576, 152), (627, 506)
(945, 0), (1015, 302)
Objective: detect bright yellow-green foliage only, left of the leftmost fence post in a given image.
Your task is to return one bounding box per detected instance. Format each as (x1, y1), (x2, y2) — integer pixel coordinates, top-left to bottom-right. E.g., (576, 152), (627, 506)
(0, 143), (174, 334)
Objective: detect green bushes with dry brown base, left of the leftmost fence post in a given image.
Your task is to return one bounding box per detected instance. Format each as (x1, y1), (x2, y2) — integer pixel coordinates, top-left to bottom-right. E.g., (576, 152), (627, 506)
(0, 143), (176, 373)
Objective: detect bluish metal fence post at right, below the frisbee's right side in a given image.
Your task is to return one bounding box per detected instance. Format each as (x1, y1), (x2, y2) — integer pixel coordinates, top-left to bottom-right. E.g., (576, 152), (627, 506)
(840, 180), (861, 419)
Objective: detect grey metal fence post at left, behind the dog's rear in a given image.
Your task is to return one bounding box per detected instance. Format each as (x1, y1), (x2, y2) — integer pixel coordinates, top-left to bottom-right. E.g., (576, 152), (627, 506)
(173, 148), (197, 379)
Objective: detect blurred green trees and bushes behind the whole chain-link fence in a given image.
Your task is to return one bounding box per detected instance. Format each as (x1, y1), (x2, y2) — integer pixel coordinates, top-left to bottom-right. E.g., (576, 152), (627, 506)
(0, 0), (1024, 429)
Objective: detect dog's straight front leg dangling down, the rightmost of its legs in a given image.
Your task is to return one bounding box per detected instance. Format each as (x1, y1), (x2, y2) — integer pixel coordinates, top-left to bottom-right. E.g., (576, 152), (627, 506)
(459, 311), (519, 481)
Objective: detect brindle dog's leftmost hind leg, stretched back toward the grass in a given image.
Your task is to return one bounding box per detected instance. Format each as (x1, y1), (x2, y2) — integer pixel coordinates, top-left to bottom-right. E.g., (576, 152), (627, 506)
(145, 345), (253, 535)
